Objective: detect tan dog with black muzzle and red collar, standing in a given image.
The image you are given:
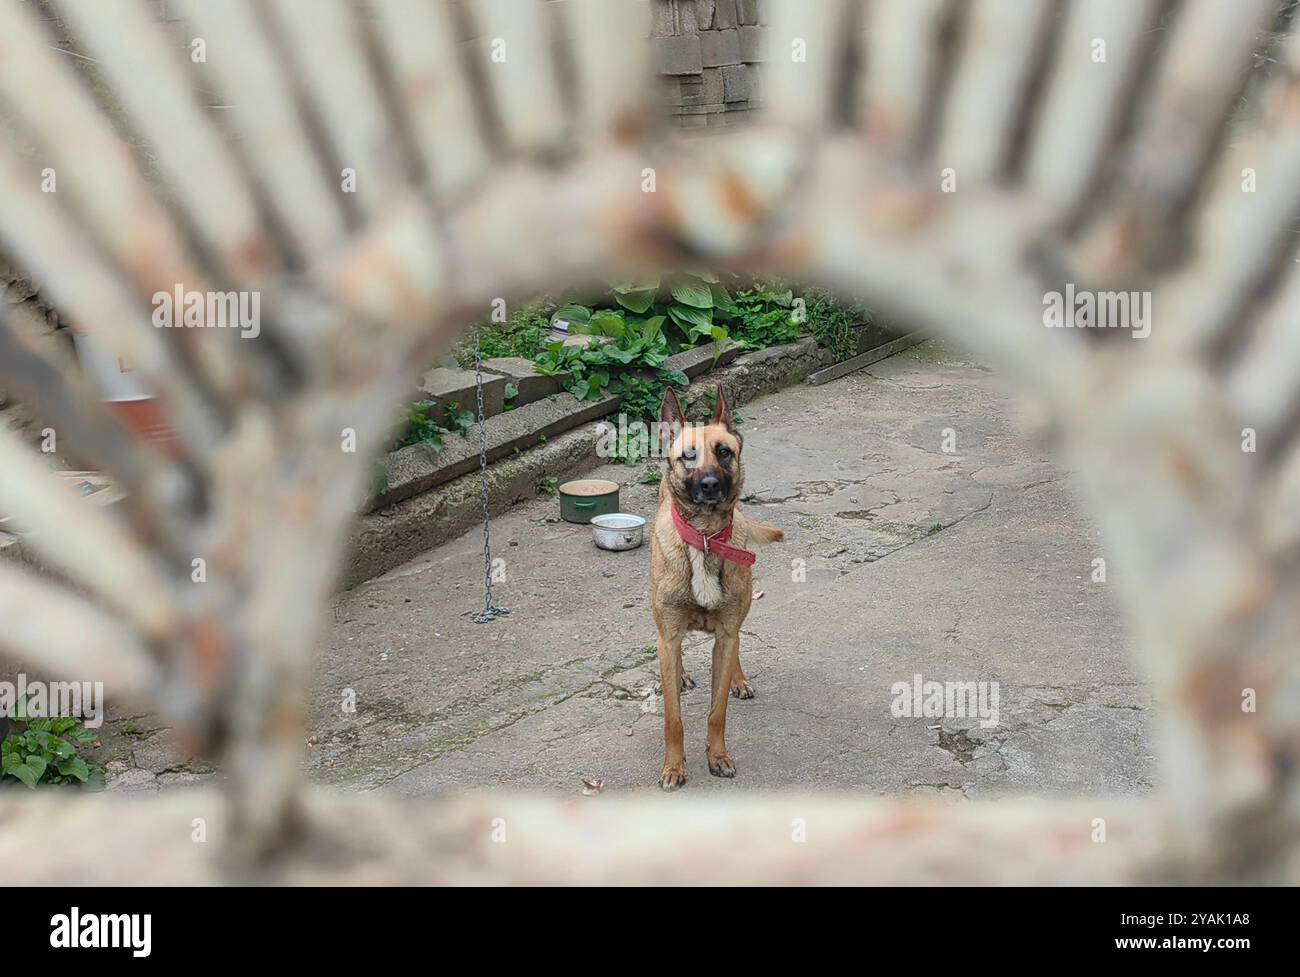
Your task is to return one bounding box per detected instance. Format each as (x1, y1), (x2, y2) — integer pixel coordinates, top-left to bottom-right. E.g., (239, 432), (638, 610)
(650, 386), (784, 790)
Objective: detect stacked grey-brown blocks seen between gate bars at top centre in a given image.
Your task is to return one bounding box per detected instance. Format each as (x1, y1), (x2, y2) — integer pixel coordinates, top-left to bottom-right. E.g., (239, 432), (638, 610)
(650, 0), (766, 129)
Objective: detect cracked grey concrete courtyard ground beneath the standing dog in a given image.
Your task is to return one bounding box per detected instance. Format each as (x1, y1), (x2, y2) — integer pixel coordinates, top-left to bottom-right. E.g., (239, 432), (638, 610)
(307, 343), (1154, 800)
